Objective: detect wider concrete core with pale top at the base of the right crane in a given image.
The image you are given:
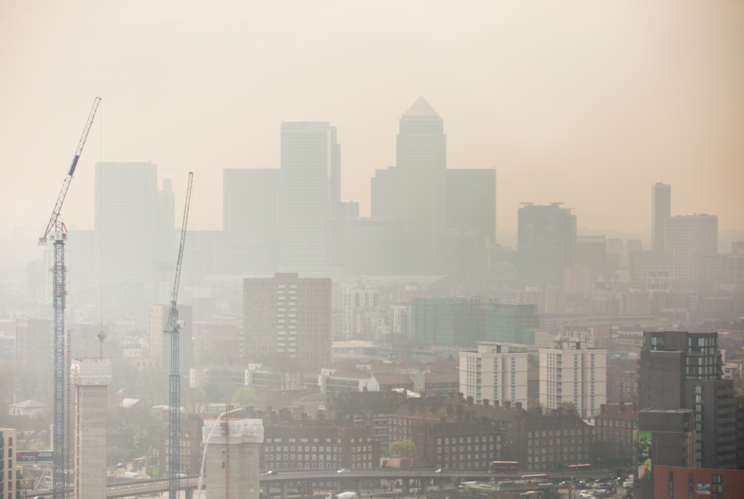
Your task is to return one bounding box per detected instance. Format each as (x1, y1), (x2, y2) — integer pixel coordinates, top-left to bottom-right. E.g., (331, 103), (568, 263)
(202, 419), (263, 499)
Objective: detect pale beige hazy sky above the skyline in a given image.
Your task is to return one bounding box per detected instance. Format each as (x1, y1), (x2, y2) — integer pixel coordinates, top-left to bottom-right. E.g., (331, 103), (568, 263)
(0, 0), (744, 240)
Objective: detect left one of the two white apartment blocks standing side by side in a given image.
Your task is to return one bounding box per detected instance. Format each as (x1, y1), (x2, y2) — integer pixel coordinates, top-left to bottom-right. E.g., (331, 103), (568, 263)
(460, 341), (527, 409)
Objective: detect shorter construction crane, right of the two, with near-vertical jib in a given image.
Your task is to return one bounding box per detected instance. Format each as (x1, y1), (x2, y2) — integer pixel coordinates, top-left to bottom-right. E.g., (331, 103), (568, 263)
(163, 172), (194, 499)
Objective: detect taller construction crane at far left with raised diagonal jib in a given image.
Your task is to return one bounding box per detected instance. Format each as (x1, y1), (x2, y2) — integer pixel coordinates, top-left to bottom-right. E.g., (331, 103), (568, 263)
(39, 97), (101, 499)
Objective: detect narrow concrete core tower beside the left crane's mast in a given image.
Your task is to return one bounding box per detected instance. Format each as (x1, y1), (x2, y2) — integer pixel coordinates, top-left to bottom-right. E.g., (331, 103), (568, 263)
(70, 360), (111, 499)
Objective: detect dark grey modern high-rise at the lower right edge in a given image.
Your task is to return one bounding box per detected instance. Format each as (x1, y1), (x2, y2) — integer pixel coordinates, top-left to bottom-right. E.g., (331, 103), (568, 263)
(638, 331), (736, 468)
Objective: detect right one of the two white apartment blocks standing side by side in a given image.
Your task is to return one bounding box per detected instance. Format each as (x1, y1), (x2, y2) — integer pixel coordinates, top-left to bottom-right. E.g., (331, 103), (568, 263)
(540, 335), (607, 419)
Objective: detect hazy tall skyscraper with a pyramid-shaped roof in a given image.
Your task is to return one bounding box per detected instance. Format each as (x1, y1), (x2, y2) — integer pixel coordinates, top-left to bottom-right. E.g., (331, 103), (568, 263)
(396, 97), (447, 275)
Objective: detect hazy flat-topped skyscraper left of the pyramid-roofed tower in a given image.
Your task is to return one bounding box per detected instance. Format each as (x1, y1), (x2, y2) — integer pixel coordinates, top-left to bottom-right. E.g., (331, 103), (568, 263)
(279, 123), (340, 273)
